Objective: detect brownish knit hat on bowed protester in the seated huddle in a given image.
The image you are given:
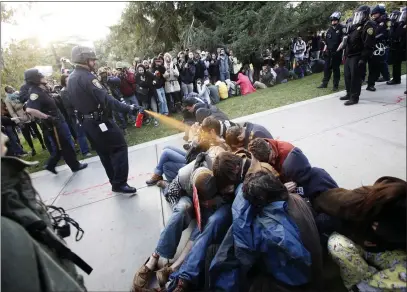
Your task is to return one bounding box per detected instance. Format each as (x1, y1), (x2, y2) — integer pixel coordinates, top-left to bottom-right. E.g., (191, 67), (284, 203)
(191, 167), (218, 201)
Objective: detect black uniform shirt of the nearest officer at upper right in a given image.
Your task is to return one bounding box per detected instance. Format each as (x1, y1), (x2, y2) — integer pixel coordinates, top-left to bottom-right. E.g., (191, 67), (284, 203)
(346, 21), (376, 62)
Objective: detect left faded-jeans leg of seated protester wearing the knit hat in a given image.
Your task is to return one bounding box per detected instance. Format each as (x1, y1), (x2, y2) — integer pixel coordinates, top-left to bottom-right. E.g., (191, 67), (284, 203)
(156, 196), (194, 259)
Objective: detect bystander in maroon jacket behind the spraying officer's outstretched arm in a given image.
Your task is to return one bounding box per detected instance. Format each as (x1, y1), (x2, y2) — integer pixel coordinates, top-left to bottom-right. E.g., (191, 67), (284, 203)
(116, 62), (139, 124)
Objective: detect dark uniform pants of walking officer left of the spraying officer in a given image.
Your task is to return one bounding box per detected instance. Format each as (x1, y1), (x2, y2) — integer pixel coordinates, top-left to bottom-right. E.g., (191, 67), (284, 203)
(44, 122), (79, 171)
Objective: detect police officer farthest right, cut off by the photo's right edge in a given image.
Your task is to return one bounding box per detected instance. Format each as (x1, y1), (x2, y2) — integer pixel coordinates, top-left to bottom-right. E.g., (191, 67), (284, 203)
(387, 7), (407, 85)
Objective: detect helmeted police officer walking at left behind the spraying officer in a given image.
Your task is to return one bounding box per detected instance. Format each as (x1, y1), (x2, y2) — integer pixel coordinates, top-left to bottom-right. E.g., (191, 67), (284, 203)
(24, 68), (88, 174)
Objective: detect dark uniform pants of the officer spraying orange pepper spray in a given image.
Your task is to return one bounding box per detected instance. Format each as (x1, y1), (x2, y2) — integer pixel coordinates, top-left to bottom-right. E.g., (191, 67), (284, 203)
(83, 119), (129, 187)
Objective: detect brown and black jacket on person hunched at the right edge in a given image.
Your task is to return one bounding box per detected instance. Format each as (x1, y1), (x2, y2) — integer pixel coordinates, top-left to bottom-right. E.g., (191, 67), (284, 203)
(313, 176), (407, 252)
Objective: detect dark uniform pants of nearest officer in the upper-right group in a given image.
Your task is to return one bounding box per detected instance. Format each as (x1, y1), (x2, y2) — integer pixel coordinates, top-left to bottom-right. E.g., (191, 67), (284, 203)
(345, 56), (362, 102)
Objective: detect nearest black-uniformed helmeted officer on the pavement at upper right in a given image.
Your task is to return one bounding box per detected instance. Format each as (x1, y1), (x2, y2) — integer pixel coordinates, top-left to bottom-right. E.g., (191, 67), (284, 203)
(340, 5), (375, 105)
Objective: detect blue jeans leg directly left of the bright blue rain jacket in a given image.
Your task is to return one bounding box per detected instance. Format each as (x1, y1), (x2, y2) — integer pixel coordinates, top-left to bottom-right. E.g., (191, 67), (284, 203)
(168, 204), (232, 291)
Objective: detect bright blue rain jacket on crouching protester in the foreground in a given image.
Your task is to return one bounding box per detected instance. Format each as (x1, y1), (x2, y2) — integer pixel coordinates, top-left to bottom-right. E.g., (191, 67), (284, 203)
(209, 185), (311, 292)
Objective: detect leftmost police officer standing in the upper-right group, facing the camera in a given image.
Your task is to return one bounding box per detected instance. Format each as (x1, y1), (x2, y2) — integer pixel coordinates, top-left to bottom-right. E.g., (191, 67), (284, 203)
(318, 11), (346, 91)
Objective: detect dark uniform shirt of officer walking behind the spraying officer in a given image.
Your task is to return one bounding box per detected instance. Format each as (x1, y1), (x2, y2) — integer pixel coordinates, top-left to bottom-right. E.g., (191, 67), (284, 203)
(27, 86), (64, 121)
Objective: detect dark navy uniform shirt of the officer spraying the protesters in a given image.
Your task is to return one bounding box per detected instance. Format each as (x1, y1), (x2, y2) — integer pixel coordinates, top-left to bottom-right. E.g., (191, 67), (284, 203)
(68, 66), (131, 115)
